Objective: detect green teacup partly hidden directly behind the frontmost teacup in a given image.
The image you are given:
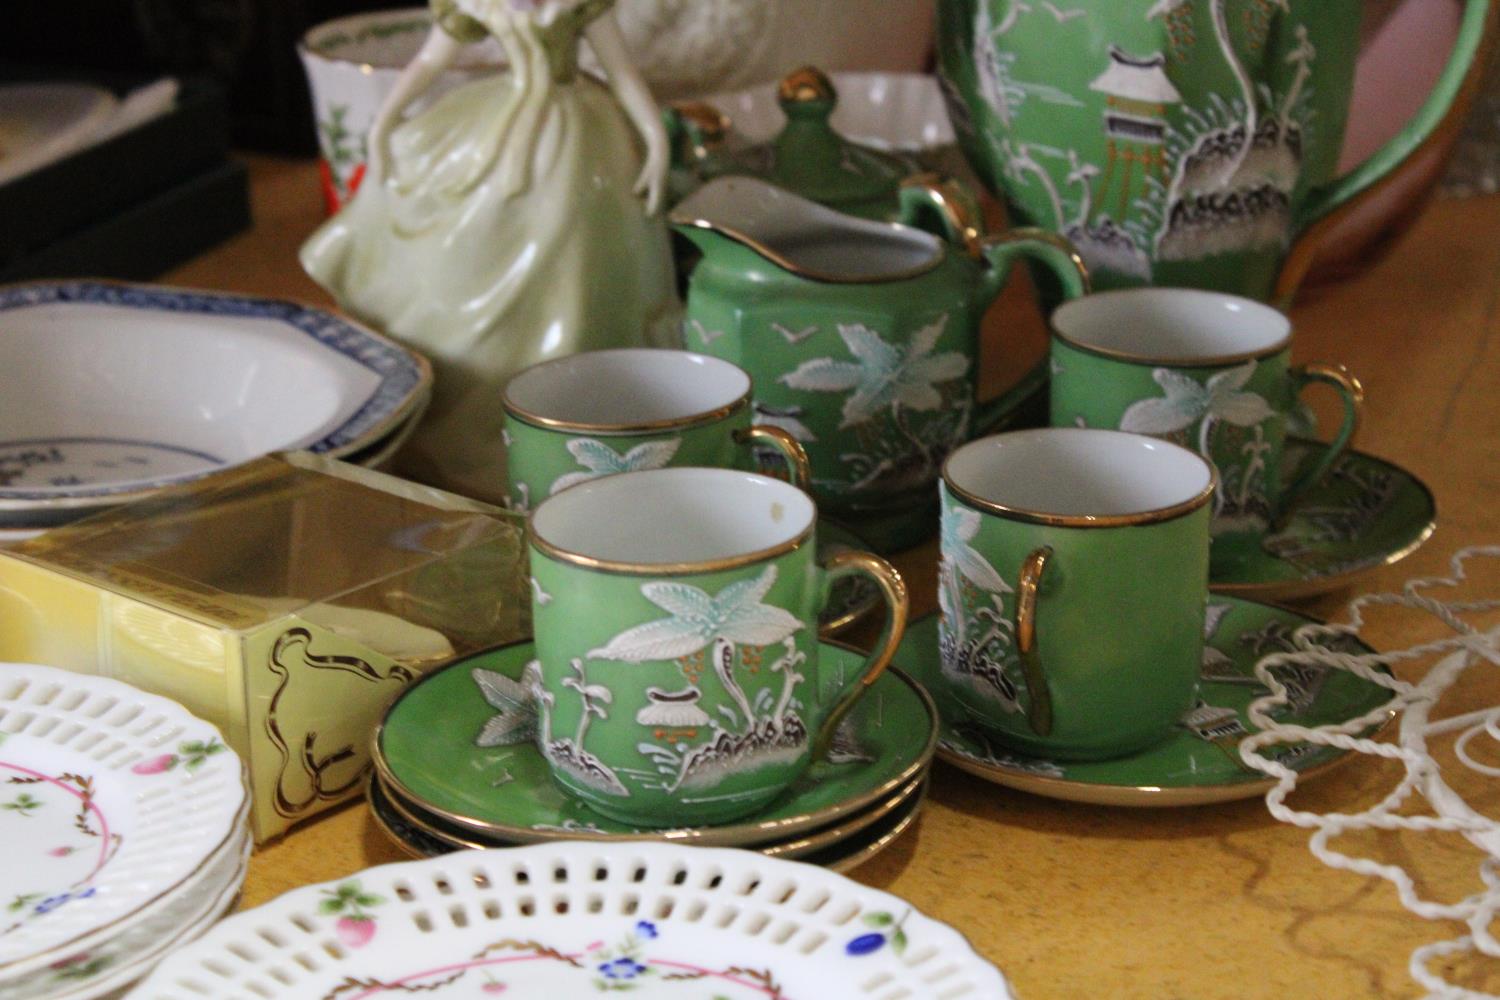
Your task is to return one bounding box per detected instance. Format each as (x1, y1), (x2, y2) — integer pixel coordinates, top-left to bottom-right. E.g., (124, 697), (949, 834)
(503, 348), (809, 510)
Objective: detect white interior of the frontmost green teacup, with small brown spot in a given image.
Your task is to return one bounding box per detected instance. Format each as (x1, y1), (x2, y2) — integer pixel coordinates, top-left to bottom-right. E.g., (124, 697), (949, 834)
(531, 468), (818, 565)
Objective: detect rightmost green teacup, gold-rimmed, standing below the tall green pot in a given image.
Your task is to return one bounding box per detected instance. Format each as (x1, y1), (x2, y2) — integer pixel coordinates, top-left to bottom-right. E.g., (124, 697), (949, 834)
(1052, 288), (1364, 570)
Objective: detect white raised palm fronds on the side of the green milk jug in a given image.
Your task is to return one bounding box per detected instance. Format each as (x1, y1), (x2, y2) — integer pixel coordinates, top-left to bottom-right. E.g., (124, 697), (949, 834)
(780, 313), (969, 430)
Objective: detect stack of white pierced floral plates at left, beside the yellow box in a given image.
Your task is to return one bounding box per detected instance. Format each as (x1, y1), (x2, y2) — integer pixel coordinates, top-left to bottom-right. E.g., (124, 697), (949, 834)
(0, 663), (251, 1000)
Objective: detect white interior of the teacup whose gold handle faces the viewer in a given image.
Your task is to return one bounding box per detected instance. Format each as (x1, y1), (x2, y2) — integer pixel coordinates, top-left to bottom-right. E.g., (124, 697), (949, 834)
(944, 427), (1214, 517)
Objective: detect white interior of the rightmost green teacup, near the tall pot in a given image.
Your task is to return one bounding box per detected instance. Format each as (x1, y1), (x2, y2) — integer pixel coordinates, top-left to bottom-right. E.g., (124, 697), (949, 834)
(1052, 288), (1292, 363)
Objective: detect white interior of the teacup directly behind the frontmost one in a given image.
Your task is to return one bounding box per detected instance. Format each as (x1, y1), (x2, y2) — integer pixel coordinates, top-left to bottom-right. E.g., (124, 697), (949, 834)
(506, 348), (750, 427)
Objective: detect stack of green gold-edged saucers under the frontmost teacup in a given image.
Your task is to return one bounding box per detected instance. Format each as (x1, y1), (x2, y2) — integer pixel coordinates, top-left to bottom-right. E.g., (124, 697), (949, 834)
(369, 642), (938, 871)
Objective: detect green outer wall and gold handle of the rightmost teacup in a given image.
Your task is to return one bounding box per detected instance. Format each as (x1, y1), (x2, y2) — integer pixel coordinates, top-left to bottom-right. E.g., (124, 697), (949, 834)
(1052, 334), (1358, 560)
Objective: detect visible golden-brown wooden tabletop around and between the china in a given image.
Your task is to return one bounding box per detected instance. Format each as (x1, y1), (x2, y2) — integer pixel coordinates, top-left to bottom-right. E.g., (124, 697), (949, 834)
(164, 157), (1500, 1000)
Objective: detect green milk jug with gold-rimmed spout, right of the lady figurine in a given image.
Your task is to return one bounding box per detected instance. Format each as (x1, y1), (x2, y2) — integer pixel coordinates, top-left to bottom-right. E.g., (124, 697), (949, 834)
(672, 177), (1088, 550)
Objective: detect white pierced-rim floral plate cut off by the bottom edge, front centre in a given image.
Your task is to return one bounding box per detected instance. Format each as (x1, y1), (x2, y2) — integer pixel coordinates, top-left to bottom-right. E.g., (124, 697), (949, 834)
(129, 843), (1011, 1000)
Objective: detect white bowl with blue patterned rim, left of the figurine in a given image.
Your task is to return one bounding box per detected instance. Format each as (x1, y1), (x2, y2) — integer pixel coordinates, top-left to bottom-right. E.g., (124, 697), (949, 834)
(0, 282), (432, 526)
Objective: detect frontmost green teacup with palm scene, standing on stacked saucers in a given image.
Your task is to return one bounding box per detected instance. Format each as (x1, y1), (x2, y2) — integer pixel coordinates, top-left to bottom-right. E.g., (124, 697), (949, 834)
(531, 468), (906, 826)
